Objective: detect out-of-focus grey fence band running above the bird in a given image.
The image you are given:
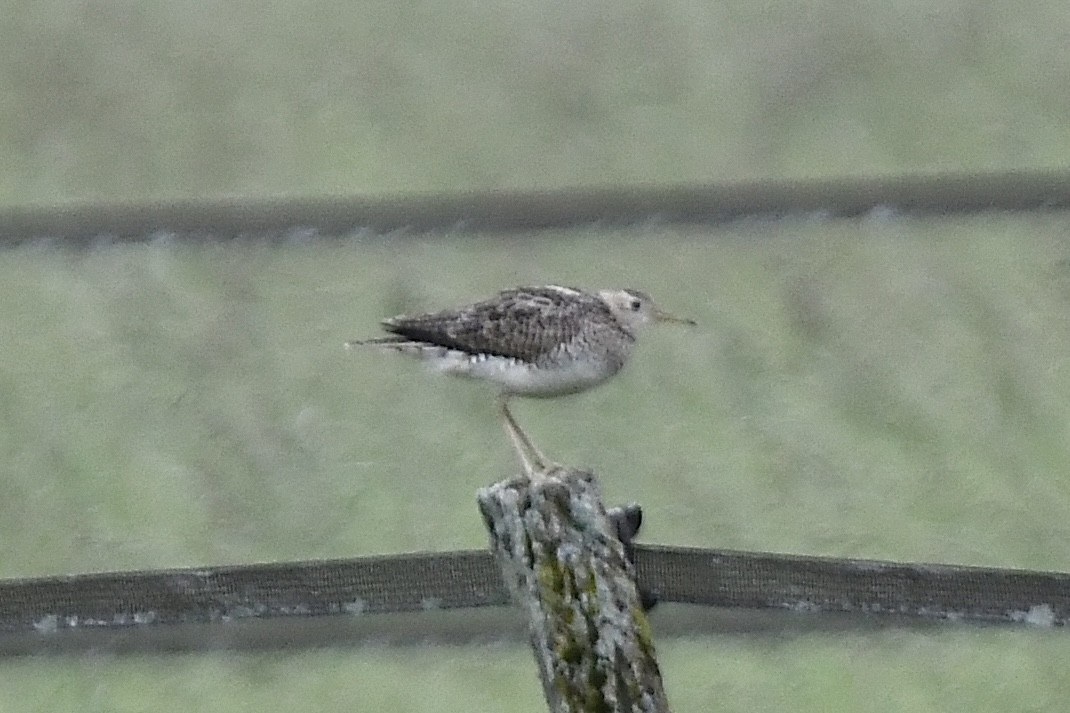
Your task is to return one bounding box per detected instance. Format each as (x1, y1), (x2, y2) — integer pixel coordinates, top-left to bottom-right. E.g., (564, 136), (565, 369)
(0, 170), (1070, 245)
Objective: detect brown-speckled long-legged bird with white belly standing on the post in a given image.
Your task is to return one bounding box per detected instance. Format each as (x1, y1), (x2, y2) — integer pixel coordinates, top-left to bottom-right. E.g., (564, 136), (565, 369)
(346, 285), (696, 479)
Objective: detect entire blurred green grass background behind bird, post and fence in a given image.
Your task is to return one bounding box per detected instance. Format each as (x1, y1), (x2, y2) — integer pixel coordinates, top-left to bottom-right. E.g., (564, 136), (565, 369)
(0, 2), (1070, 712)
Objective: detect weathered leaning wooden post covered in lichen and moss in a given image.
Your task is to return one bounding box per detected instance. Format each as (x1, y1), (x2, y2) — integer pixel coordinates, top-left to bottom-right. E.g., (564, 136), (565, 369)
(478, 469), (669, 713)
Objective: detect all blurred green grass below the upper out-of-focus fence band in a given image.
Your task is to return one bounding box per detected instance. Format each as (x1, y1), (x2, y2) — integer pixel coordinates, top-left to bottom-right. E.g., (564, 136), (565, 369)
(0, 219), (1070, 711)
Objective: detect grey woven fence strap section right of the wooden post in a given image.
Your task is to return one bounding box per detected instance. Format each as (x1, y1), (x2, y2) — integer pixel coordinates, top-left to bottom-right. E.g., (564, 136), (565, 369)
(636, 546), (1070, 626)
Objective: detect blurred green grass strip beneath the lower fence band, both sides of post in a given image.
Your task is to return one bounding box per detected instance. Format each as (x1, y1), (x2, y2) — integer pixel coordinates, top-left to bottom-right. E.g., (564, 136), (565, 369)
(0, 629), (1070, 713)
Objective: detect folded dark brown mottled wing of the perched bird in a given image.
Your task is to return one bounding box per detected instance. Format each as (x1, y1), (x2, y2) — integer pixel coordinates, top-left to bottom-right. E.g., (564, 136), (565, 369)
(383, 287), (605, 363)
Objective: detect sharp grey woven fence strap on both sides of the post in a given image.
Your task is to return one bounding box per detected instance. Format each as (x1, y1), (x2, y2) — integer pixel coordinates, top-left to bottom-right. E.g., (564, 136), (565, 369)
(0, 545), (1070, 650)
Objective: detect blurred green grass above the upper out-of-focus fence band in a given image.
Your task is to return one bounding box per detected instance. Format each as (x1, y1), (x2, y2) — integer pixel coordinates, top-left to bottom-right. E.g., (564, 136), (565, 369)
(6, 0), (1070, 206)
